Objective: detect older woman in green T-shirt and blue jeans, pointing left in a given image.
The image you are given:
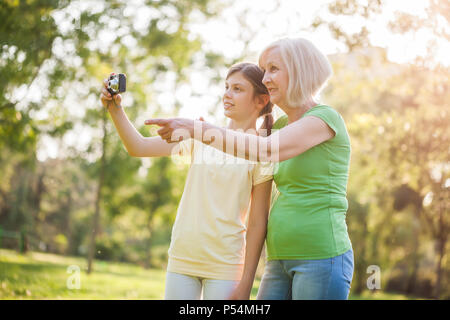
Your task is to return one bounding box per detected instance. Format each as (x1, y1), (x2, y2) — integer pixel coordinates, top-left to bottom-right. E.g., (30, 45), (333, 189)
(146, 39), (354, 299)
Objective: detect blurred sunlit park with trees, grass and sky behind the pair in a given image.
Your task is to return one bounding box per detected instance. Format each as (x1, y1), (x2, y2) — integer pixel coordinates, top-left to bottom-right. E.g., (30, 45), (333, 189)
(0, 0), (450, 299)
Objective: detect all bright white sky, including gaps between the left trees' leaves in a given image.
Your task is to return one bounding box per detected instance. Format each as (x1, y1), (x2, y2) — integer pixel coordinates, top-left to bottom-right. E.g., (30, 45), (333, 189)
(33, 0), (450, 160)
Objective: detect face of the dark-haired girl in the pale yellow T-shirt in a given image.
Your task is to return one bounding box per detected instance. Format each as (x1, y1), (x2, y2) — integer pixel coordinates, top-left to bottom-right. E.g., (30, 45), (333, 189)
(222, 71), (259, 121)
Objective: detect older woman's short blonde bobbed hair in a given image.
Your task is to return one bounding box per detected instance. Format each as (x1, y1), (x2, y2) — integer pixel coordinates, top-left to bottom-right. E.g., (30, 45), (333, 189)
(259, 38), (333, 107)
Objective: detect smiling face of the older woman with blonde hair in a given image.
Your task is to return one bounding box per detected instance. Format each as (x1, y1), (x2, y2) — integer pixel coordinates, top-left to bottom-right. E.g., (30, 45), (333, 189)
(259, 47), (289, 108)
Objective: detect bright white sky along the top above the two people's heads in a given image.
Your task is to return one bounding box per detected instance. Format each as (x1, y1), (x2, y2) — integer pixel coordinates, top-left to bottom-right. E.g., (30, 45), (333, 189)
(186, 0), (442, 62)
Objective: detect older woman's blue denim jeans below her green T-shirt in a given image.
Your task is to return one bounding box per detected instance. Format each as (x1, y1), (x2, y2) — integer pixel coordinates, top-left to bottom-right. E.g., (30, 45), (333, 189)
(256, 249), (354, 300)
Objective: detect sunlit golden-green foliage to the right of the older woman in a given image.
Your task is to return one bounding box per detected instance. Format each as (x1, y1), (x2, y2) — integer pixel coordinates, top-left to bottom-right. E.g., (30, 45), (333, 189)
(324, 49), (450, 297)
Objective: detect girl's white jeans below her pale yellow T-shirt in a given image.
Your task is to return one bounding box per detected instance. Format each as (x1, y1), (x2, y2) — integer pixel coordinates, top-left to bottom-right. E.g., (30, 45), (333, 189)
(164, 272), (239, 300)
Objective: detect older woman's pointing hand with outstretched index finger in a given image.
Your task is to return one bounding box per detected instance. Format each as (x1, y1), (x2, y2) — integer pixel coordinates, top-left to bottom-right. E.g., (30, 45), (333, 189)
(145, 118), (197, 143)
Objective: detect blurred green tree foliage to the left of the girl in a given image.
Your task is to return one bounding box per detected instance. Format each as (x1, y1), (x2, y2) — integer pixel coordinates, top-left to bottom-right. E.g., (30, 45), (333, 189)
(0, 0), (220, 270)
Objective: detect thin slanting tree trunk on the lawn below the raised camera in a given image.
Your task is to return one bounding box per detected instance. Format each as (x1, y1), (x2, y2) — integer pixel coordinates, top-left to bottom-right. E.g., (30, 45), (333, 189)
(87, 108), (107, 274)
